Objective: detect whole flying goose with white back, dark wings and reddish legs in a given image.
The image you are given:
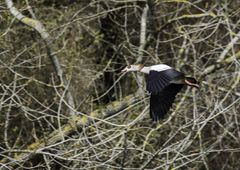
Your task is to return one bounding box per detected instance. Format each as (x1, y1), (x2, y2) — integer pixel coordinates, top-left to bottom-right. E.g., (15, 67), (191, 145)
(122, 64), (199, 121)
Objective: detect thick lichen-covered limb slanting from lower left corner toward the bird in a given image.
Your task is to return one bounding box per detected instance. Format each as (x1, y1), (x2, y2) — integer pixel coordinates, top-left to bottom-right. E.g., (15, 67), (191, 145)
(0, 94), (142, 167)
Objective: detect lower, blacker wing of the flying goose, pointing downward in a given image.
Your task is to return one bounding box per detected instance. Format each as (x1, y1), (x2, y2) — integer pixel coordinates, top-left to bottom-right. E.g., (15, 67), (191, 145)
(150, 84), (183, 121)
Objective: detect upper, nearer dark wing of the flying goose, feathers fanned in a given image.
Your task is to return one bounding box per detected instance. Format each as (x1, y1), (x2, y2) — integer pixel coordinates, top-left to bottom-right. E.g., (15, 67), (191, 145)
(147, 69), (184, 94)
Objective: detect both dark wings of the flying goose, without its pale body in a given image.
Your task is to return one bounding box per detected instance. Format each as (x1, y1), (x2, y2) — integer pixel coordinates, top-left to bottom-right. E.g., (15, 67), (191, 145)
(147, 69), (184, 121)
